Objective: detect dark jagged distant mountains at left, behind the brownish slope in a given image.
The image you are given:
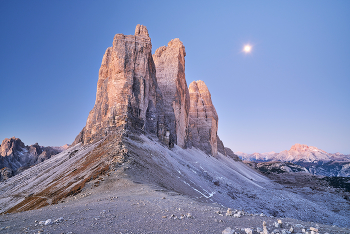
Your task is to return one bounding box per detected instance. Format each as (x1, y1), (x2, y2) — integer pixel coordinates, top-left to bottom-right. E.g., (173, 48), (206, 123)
(0, 137), (69, 181)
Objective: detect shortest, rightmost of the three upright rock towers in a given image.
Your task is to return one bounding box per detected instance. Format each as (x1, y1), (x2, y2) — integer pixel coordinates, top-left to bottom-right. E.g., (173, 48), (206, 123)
(189, 80), (218, 156)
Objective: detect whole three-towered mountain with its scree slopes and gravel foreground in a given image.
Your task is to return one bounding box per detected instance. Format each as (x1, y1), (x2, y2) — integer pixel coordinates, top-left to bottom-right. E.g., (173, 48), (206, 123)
(0, 25), (350, 233)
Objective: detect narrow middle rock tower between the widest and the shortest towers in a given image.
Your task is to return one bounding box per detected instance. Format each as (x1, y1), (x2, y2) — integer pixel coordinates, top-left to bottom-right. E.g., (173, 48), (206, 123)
(153, 38), (190, 148)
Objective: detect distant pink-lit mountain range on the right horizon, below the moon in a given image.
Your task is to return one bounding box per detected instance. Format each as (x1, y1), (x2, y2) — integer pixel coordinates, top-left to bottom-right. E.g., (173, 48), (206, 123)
(235, 144), (350, 177)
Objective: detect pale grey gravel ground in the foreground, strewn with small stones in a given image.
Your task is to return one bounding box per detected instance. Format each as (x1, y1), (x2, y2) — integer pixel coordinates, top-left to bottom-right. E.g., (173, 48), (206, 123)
(0, 172), (350, 233)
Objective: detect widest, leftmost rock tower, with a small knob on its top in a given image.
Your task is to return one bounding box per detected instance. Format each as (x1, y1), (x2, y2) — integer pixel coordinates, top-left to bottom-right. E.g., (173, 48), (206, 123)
(73, 25), (171, 145)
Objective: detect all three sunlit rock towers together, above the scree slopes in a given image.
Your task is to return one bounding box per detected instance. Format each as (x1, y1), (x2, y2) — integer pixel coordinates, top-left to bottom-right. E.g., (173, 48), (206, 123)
(73, 25), (230, 156)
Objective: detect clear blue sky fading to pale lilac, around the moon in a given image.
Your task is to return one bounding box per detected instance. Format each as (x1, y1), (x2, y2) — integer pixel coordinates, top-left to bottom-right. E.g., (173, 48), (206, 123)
(0, 0), (350, 154)
